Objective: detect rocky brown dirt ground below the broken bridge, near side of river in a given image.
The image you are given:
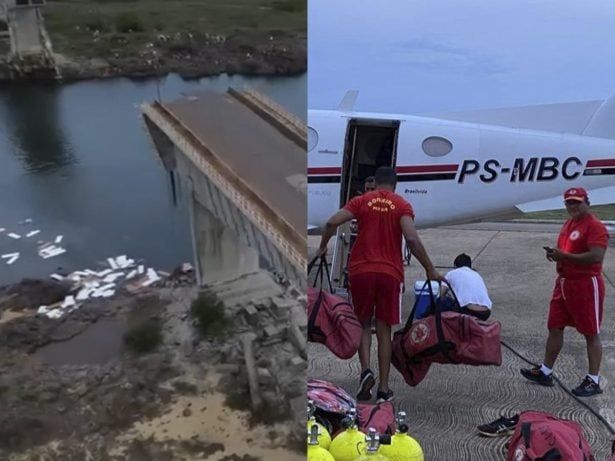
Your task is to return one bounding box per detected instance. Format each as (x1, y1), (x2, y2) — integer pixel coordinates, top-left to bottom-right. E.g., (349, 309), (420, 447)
(0, 270), (305, 461)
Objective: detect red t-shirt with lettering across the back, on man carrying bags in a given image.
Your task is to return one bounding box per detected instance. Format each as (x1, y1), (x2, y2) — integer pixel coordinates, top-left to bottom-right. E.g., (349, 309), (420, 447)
(344, 190), (414, 282)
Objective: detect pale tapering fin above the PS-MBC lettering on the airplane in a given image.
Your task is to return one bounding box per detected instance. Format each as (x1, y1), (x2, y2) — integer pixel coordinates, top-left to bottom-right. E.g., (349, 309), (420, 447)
(421, 100), (604, 134)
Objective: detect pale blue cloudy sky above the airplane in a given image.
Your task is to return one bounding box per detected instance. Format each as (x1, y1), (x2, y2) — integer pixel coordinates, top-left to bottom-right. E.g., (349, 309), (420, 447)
(308, 0), (615, 114)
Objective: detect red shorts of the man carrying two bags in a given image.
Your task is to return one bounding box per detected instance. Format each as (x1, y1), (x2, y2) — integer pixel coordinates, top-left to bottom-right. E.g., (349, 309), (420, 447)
(348, 272), (404, 326)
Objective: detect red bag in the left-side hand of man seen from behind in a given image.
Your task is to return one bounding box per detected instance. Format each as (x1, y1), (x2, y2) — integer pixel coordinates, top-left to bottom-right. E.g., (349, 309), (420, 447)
(307, 257), (363, 359)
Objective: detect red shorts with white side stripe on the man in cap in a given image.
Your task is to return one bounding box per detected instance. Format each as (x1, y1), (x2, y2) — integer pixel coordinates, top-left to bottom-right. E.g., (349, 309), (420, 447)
(547, 275), (604, 336)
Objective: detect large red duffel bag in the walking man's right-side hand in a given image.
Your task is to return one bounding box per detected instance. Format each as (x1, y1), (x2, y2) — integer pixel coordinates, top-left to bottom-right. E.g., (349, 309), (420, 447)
(392, 282), (502, 386)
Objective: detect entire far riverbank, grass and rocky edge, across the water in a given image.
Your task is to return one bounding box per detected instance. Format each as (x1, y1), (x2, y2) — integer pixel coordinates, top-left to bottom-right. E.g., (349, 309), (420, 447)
(0, 0), (307, 81)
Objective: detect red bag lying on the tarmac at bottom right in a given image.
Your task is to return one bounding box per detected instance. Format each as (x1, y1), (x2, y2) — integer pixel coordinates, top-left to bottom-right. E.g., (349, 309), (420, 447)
(506, 411), (595, 461)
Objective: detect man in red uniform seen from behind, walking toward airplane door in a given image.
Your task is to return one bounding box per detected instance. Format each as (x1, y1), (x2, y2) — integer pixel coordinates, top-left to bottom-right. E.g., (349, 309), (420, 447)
(318, 167), (442, 402)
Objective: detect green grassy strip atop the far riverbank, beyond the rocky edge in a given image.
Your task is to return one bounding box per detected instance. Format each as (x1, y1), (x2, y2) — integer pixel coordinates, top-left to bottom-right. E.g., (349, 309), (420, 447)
(43, 0), (307, 58)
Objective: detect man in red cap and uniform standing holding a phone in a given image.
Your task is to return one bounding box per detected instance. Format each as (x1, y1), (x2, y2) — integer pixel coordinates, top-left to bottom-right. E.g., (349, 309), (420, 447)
(521, 187), (609, 397)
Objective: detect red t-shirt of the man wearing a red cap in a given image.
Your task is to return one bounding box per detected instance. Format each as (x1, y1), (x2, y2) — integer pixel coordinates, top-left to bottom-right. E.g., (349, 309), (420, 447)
(556, 213), (609, 278)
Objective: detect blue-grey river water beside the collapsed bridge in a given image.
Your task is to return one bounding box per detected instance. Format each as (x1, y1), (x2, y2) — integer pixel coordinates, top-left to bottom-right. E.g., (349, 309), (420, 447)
(0, 75), (307, 284)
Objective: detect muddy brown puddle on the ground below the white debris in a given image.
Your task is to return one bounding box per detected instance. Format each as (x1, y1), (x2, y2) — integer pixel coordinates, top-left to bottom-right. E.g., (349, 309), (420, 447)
(36, 319), (125, 365)
